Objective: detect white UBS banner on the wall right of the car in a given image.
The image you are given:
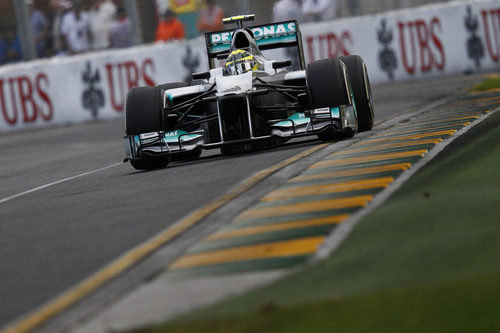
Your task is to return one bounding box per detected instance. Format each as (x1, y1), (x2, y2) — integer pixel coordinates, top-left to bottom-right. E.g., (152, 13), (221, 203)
(303, 0), (500, 83)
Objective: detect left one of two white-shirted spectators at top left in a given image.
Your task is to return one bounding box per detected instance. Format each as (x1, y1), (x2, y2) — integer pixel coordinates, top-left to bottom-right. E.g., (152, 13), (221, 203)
(61, 0), (91, 54)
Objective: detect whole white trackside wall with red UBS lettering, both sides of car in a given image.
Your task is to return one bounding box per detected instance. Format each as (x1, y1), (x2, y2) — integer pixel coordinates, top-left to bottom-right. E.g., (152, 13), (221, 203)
(0, 0), (500, 133)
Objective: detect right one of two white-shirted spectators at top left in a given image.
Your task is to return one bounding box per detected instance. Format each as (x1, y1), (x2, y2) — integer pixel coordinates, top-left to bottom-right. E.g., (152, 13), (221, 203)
(89, 0), (116, 50)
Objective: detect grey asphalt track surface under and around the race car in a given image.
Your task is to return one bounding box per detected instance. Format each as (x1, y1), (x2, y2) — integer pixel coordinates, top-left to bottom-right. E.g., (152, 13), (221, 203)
(0, 72), (480, 328)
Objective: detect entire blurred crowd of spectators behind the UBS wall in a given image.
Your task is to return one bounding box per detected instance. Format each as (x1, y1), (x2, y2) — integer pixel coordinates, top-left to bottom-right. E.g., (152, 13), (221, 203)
(0, 0), (336, 64)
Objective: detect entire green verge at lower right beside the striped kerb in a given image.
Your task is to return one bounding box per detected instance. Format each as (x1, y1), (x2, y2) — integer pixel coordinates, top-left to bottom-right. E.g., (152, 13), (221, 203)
(143, 112), (500, 332)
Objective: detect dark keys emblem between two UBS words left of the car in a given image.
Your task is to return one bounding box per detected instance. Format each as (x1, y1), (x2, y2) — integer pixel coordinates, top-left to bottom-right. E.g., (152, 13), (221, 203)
(82, 61), (104, 119)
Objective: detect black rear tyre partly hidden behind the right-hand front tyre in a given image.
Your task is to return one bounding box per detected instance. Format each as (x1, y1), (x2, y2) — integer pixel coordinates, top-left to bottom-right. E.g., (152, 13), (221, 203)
(340, 55), (374, 132)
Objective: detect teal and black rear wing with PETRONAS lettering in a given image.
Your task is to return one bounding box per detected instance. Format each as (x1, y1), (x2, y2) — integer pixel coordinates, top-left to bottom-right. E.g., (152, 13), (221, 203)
(205, 21), (305, 69)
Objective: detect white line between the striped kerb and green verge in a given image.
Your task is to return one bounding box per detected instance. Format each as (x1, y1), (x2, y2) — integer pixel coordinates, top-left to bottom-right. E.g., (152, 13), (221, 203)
(310, 109), (500, 262)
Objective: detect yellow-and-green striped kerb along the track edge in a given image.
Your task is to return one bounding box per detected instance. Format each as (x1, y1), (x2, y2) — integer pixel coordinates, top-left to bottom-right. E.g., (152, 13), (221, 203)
(166, 87), (497, 279)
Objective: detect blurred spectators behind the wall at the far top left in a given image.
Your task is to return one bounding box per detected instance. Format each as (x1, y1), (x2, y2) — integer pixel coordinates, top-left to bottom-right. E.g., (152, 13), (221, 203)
(0, 0), (132, 64)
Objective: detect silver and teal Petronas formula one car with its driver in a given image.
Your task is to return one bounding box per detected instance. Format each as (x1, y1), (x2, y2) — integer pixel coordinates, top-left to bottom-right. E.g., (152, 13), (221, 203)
(125, 15), (374, 170)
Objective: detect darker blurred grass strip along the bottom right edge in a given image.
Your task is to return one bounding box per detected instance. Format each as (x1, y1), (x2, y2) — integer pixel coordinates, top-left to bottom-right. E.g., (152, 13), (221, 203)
(140, 274), (500, 333)
